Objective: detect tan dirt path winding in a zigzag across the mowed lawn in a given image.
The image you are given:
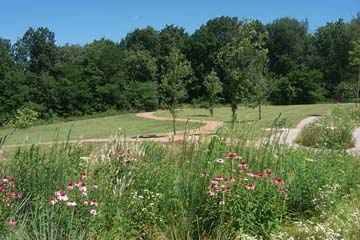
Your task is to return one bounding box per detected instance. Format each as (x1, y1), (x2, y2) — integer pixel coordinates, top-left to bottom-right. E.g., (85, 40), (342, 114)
(3, 112), (224, 148)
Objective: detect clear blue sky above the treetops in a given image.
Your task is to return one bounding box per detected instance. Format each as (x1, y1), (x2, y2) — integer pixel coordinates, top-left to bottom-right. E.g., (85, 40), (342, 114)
(0, 0), (360, 45)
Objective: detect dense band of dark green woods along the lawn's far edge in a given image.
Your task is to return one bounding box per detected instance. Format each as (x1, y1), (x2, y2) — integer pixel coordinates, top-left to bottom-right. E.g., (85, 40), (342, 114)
(0, 15), (360, 124)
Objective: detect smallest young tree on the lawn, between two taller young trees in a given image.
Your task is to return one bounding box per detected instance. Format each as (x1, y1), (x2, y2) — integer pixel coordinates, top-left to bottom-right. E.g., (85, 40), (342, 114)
(204, 70), (223, 116)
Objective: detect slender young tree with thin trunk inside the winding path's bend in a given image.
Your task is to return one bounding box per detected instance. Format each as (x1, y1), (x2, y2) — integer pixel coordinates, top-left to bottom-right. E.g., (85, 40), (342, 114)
(160, 48), (192, 135)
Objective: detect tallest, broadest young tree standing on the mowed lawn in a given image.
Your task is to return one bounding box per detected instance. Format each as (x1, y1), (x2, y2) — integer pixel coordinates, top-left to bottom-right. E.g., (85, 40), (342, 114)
(217, 21), (267, 122)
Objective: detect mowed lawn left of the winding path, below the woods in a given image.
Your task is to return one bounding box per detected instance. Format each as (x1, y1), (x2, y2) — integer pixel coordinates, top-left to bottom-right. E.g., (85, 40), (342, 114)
(0, 114), (201, 145)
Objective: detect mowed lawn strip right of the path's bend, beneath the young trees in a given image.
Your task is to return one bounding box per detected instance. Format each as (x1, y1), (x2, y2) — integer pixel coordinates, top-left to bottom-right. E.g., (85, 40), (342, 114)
(156, 104), (344, 128)
